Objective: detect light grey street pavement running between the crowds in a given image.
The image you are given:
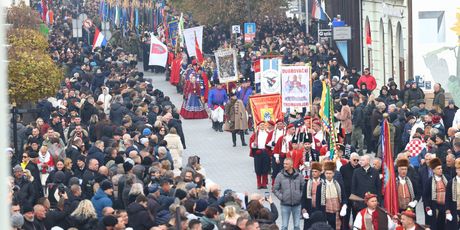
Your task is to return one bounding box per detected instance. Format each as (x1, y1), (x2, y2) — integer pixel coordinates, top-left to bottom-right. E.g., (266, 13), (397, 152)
(144, 72), (425, 227)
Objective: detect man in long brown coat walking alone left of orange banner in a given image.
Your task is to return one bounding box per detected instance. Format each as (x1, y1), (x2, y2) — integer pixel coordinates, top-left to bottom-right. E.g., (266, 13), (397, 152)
(225, 92), (248, 147)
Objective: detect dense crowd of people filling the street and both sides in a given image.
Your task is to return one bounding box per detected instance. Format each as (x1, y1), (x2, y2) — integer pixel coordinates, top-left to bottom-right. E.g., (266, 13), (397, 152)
(6, 0), (460, 230)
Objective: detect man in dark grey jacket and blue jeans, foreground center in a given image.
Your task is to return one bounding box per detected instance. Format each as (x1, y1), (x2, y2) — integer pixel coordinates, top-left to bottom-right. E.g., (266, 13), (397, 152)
(273, 158), (305, 230)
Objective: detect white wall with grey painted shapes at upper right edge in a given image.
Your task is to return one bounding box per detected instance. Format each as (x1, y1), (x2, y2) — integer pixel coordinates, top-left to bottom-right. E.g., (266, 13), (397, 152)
(413, 0), (460, 93)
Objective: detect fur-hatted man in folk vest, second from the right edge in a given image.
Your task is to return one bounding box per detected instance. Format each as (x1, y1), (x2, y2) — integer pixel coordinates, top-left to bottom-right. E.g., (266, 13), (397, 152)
(423, 158), (447, 230)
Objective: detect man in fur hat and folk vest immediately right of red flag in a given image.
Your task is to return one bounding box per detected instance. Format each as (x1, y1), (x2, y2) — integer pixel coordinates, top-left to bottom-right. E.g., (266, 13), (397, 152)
(396, 158), (421, 212)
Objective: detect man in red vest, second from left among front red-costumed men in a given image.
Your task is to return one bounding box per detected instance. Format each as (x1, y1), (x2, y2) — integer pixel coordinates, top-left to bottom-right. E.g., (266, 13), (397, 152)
(272, 124), (295, 184)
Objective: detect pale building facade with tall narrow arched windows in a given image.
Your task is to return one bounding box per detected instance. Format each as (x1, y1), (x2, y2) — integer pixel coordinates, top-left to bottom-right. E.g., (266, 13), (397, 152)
(361, 0), (409, 88)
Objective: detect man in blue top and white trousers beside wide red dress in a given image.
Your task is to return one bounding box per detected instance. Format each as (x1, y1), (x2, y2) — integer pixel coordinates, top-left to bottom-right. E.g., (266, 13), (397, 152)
(208, 82), (228, 132)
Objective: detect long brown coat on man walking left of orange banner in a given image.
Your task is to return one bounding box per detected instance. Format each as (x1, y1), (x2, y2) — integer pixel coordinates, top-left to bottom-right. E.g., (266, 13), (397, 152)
(225, 99), (248, 131)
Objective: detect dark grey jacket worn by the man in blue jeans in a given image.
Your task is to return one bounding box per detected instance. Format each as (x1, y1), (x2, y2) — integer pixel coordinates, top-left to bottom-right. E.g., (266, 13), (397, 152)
(273, 170), (305, 206)
